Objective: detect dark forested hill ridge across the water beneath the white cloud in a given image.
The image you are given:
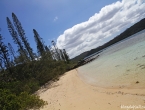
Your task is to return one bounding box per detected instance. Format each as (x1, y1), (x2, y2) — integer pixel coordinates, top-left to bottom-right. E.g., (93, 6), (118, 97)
(72, 18), (145, 62)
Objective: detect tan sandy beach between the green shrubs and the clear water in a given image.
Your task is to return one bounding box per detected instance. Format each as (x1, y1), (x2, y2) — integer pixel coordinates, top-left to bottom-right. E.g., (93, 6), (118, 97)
(38, 69), (145, 110)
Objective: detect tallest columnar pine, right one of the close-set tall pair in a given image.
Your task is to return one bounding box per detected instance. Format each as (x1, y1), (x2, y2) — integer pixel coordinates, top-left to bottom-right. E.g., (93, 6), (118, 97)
(12, 13), (34, 60)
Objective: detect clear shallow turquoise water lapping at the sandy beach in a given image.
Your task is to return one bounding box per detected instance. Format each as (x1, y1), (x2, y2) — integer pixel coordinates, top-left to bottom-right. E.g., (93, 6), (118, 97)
(77, 30), (145, 88)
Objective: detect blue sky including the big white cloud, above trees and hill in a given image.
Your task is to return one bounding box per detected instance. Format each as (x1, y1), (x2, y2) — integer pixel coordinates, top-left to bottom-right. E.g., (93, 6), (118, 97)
(0, 0), (145, 58)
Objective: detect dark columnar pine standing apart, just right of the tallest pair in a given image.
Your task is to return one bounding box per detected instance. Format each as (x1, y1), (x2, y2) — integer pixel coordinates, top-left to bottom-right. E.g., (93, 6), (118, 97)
(33, 29), (45, 56)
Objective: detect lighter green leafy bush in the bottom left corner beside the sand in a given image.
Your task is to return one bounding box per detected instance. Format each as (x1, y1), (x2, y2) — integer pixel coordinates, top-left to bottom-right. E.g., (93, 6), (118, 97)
(0, 89), (47, 110)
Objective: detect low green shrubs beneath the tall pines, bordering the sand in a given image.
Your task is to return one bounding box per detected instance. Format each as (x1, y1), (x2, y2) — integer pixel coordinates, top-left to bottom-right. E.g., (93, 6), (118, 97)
(0, 60), (72, 110)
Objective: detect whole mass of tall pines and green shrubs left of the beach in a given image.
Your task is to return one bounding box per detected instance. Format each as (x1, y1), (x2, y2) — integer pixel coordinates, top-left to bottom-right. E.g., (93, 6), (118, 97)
(0, 13), (71, 110)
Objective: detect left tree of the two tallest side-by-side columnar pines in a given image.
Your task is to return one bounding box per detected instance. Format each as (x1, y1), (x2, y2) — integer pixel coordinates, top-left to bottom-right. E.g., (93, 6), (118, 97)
(6, 17), (28, 59)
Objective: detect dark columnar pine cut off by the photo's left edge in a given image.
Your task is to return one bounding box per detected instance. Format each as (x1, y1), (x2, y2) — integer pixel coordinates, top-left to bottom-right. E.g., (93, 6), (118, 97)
(0, 34), (12, 73)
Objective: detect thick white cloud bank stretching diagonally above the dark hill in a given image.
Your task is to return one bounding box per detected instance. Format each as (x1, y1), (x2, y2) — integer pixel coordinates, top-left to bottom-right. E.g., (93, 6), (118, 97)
(57, 0), (145, 58)
